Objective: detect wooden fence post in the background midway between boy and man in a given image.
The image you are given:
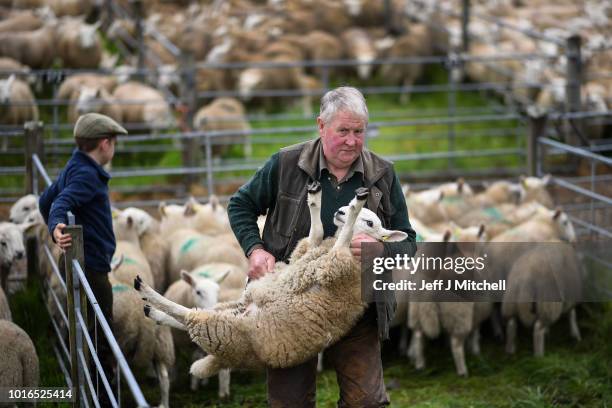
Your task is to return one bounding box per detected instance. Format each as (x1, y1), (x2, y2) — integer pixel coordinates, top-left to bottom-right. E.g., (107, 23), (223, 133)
(181, 52), (200, 191)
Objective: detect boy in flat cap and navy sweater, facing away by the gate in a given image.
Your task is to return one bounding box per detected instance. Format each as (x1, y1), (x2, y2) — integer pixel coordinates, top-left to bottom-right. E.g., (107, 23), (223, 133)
(39, 113), (127, 405)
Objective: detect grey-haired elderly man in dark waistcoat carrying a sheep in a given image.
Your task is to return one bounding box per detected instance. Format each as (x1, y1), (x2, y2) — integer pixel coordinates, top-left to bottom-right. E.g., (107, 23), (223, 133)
(228, 87), (416, 408)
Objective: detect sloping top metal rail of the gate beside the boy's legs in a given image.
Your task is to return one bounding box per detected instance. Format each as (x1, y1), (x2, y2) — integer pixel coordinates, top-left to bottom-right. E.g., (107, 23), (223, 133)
(73, 261), (149, 407)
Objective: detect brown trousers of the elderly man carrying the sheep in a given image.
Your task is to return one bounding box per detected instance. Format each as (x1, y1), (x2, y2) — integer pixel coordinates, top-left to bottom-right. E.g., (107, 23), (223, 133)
(267, 306), (389, 408)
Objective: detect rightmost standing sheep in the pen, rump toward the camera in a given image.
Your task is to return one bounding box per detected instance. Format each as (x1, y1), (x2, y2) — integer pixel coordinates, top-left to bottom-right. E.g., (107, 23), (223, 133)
(501, 241), (582, 357)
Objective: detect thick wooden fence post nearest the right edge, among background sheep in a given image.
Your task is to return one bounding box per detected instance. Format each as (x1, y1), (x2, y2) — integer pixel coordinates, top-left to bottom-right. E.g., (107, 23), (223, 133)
(565, 35), (584, 146)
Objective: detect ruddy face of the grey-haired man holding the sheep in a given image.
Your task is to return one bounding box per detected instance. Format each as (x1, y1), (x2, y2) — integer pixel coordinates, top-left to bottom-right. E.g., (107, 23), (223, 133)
(317, 111), (366, 169)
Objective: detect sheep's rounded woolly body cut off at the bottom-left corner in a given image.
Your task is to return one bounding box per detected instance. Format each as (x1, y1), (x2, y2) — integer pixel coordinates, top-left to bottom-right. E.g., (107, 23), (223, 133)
(0, 320), (39, 388)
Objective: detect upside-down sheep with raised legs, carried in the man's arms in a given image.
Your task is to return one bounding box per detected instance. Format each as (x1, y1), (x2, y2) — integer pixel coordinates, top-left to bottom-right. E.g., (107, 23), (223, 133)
(134, 181), (406, 378)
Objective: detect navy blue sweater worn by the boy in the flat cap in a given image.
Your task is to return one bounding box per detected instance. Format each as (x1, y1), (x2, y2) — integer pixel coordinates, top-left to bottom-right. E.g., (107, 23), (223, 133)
(39, 150), (116, 272)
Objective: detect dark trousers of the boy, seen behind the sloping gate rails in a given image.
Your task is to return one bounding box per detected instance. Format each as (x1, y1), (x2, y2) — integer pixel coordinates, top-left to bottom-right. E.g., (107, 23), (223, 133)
(59, 254), (115, 407)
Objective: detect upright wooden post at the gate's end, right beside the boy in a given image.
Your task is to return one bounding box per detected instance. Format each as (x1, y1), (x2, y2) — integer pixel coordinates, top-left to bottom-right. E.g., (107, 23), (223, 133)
(64, 220), (87, 402)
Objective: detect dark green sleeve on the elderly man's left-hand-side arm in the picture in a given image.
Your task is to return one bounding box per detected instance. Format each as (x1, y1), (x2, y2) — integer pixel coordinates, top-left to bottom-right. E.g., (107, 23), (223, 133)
(227, 153), (279, 256)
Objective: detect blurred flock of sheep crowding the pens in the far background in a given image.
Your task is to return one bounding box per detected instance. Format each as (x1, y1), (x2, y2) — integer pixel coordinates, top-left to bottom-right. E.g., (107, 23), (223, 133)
(0, 0), (612, 154)
